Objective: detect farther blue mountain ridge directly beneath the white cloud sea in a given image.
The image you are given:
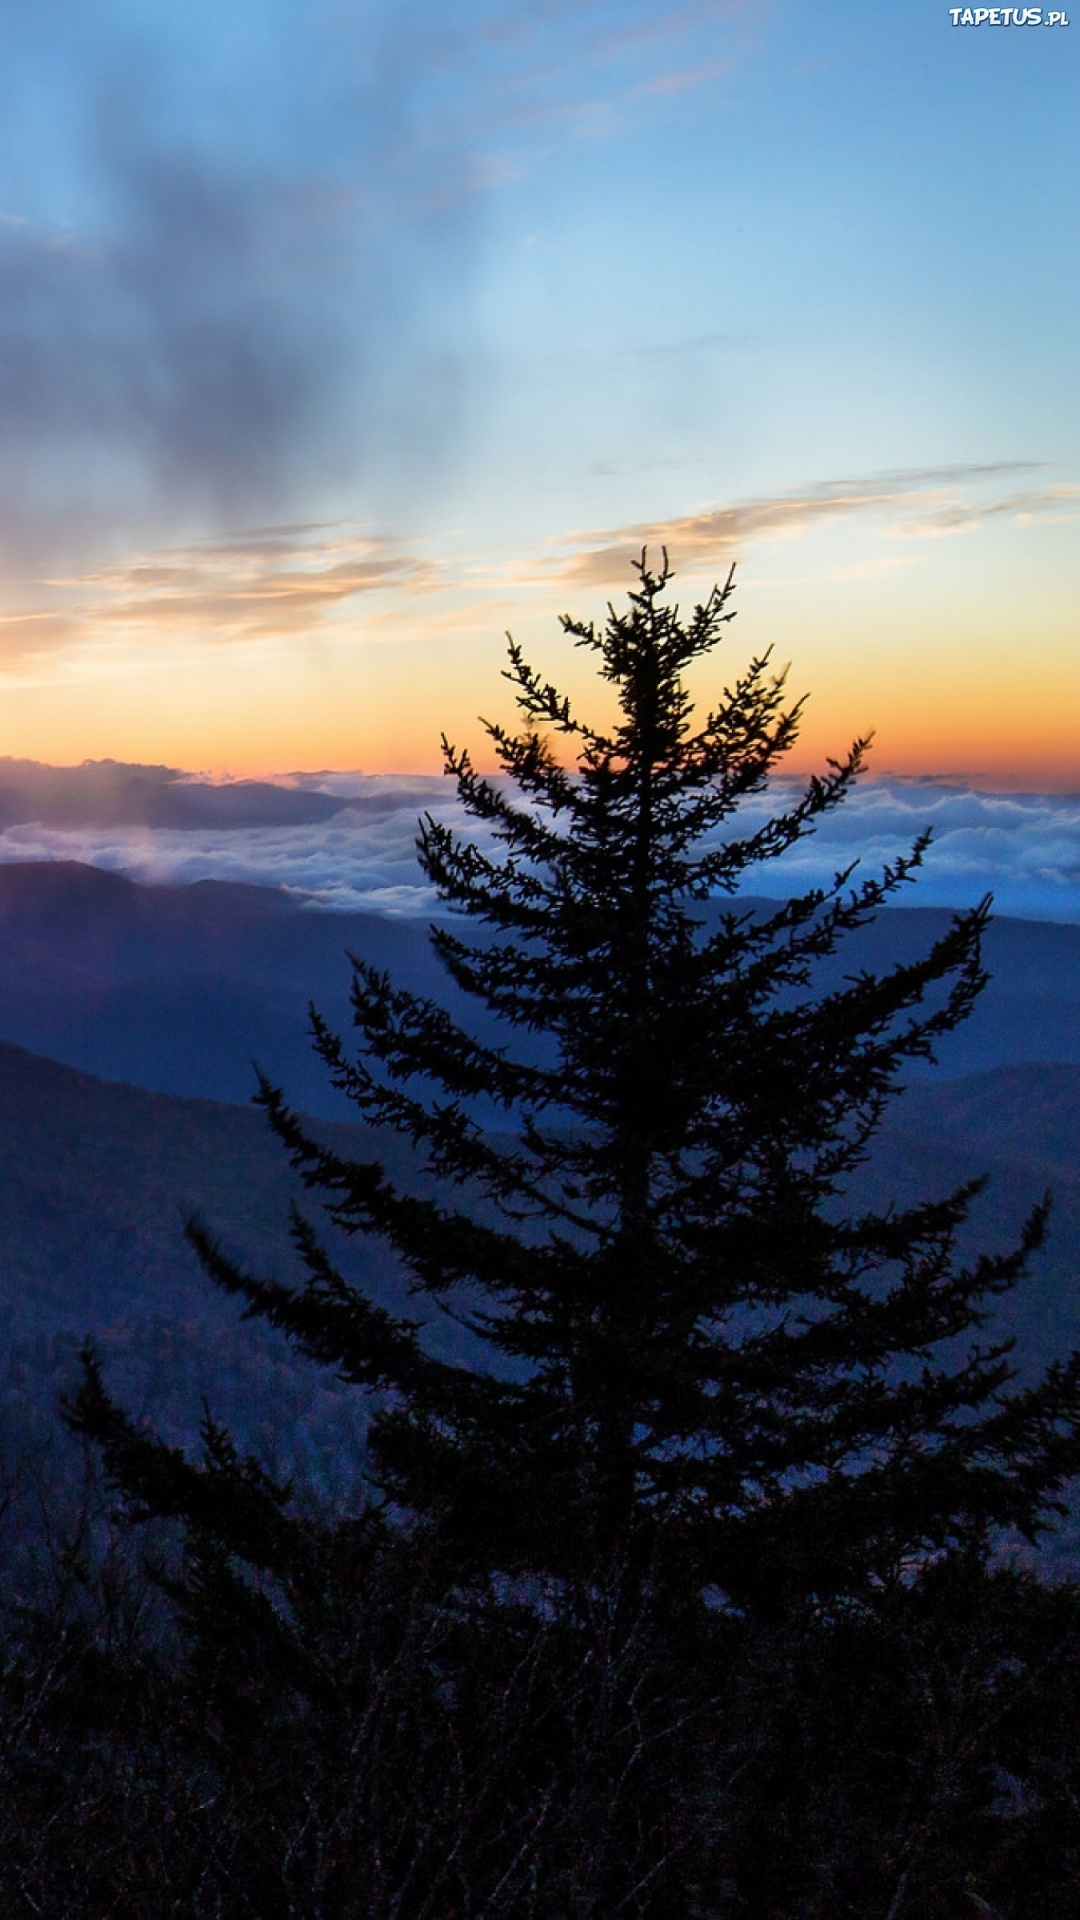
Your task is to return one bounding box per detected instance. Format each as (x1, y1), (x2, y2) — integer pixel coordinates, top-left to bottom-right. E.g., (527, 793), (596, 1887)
(0, 862), (1080, 1119)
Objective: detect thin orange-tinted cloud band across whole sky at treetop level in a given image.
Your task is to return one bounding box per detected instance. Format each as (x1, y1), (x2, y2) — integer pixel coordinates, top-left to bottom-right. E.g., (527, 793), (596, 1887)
(0, 461), (1080, 660)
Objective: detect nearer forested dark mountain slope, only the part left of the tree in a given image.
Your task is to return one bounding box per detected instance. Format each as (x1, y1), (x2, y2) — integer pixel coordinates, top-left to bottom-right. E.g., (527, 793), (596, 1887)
(0, 1044), (459, 1486)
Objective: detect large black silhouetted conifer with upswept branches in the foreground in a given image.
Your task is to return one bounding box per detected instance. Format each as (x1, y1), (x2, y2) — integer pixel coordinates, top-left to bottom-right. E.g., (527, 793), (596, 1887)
(75, 559), (1080, 1607)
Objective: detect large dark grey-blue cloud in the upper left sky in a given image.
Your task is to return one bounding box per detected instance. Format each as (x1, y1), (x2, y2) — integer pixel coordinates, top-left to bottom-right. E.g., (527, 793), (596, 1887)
(0, 0), (484, 570)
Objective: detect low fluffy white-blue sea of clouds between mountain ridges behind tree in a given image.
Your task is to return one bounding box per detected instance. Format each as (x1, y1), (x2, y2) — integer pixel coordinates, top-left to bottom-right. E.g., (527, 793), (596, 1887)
(0, 768), (1080, 922)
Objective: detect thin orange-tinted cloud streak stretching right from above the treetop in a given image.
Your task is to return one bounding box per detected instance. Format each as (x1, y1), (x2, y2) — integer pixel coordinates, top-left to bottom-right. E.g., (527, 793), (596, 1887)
(538, 461), (1053, 586)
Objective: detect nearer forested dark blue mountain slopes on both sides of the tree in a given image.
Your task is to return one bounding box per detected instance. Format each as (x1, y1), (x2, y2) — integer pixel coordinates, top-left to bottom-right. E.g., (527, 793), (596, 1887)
(0, 1044), (1080, 1551)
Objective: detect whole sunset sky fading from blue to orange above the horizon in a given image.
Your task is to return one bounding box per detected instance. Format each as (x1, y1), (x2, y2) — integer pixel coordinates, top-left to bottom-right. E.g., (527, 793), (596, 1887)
(0, 0), (1080, 791)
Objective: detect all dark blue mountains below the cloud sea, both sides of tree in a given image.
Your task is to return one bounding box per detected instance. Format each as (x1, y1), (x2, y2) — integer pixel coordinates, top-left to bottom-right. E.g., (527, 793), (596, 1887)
(0, 862), (1080, 1553)
